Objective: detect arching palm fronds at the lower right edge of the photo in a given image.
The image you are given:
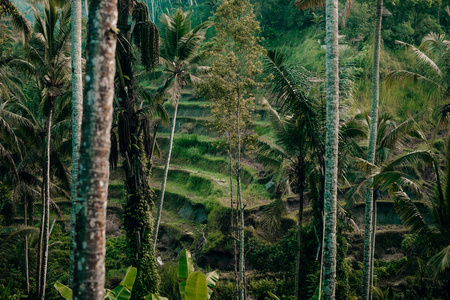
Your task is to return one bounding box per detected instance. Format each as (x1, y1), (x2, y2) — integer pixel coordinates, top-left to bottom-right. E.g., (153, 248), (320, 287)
(374, 136), (450, 299)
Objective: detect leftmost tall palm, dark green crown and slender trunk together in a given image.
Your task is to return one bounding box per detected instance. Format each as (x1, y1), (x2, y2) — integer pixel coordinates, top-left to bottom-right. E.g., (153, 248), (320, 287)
(11, 0), (70, 298)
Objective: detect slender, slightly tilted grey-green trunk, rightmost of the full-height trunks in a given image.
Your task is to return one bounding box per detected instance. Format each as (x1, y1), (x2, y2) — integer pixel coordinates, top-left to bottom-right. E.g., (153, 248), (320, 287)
(362, 0), (383, 300)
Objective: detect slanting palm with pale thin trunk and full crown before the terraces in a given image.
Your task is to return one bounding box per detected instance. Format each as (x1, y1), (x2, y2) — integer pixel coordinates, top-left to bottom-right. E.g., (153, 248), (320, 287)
(153, 8), (211, 249)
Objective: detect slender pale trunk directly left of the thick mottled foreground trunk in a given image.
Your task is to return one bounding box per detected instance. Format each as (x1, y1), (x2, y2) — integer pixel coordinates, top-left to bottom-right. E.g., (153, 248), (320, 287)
(69, 0), (83, 289)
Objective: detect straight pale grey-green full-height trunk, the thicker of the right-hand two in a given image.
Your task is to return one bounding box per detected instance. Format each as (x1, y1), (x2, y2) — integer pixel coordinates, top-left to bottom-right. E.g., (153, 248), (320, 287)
(323, 0), (339, 300)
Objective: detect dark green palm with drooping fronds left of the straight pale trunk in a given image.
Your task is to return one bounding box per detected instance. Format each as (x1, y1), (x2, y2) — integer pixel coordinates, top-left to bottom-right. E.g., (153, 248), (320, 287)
(259, 52), (320, 299)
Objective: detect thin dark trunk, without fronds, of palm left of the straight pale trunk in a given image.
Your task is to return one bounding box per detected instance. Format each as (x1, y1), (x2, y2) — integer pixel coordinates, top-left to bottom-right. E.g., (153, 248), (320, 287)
(295, 155), (305, 300)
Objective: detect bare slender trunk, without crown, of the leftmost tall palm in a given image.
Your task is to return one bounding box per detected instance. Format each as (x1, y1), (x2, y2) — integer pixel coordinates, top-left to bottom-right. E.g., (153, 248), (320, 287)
(39, 101), (53, 299)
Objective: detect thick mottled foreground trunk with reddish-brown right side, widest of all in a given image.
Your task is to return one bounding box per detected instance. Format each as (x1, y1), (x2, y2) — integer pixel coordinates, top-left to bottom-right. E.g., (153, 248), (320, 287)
(73, 0), (117, 299)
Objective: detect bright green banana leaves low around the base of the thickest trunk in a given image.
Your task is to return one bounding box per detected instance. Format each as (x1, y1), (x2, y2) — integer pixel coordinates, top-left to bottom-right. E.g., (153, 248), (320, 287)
(54, 267), (137, 300)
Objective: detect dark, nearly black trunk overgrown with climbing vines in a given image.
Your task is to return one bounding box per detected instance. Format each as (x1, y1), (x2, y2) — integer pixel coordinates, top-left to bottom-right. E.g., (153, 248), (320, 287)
(117, 0), (159, 299)
